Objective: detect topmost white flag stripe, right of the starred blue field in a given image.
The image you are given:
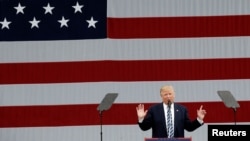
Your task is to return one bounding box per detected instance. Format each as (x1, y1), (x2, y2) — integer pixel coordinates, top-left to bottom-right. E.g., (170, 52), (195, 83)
(107, 0), (250, 17)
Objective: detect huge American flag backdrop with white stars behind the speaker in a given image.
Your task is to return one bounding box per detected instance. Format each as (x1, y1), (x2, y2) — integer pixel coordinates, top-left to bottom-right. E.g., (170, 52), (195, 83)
(0, 0), (250, 141)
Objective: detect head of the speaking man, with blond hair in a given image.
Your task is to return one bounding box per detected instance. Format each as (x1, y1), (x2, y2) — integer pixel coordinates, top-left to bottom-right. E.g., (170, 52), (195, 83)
(160, 87), (175, 104)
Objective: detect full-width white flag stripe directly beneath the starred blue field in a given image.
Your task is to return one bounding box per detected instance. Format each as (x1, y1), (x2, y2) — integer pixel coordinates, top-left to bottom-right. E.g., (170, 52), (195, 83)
(0, 37), (250, 63)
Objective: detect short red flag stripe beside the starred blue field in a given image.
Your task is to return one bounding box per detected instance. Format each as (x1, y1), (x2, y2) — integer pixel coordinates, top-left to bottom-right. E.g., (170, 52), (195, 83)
(108, 15), (250, 38)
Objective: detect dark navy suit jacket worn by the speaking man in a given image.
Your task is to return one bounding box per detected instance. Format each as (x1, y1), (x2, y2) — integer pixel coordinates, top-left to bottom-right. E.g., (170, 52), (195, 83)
(138, 103), (202, 138)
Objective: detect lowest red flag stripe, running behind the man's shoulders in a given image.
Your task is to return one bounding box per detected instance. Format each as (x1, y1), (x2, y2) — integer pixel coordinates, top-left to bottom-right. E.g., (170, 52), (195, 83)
(0, 101), (250, 128)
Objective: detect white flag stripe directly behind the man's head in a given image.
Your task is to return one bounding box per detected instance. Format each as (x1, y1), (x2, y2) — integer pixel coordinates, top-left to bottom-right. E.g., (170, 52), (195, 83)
(0, 79), (250, 106)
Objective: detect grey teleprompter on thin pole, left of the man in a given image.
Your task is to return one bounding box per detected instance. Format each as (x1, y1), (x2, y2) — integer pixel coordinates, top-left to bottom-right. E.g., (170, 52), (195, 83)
(97, 93), (118, 141)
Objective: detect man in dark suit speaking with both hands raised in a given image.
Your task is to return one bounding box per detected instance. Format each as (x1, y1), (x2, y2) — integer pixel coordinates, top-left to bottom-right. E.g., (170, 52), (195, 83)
(136, 85), (206, 138)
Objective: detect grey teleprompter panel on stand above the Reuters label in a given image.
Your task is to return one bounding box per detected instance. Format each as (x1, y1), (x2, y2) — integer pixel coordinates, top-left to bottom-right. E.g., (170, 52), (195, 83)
(217, 91), (240, 125)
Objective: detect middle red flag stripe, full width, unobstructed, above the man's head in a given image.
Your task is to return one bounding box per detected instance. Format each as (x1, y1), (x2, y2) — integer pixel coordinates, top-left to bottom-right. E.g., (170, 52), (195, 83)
(0, 58), (250, 84)
